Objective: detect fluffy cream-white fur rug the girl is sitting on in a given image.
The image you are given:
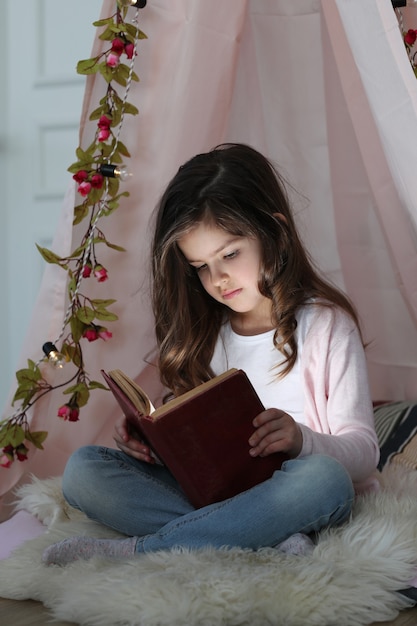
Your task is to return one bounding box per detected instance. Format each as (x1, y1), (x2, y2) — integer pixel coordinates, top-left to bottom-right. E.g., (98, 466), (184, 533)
(0, 467), (417, 626)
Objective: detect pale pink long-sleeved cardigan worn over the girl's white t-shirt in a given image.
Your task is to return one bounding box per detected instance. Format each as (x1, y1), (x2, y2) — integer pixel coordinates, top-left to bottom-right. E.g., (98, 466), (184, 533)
(300, 306), (379, 491)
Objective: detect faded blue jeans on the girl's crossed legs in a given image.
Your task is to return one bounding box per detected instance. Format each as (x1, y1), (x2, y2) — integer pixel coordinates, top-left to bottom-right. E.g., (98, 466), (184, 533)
(63, 446), (354, 553)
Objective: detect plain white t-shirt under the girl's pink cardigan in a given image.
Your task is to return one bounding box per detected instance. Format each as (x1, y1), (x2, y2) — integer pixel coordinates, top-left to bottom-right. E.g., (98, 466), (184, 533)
(211, 308), (310, 424)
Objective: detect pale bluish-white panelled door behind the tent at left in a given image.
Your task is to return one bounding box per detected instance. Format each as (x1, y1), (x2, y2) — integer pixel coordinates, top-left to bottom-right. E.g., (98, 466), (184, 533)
(0, 0), (102, 411)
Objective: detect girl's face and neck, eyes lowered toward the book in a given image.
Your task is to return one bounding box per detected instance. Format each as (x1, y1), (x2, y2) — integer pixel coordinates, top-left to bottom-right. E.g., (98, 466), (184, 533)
(178, 222), (274, 335)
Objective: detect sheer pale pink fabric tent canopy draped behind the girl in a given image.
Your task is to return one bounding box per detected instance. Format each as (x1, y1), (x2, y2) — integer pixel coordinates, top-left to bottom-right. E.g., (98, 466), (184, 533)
(0, 0), (417, 517)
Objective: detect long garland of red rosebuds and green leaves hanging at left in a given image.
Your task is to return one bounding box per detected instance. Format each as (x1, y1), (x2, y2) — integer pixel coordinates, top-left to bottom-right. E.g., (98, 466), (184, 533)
(0, 0), (146, 468)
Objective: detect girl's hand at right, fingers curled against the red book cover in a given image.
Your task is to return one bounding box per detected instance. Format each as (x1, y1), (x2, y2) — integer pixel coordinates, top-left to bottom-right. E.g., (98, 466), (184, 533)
(249, 409), (303, 458)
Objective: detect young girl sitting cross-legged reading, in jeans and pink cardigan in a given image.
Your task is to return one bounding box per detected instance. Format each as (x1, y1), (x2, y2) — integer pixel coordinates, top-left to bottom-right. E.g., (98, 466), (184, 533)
(44, 144), (379, 564)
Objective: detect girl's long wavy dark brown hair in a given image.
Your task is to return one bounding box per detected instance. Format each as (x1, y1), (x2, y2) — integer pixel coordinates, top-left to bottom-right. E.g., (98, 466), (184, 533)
(152, 144), (359, 395)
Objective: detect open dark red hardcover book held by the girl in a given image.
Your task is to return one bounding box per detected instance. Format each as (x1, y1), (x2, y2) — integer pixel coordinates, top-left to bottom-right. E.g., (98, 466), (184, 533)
(102, 368), (288, 508)
